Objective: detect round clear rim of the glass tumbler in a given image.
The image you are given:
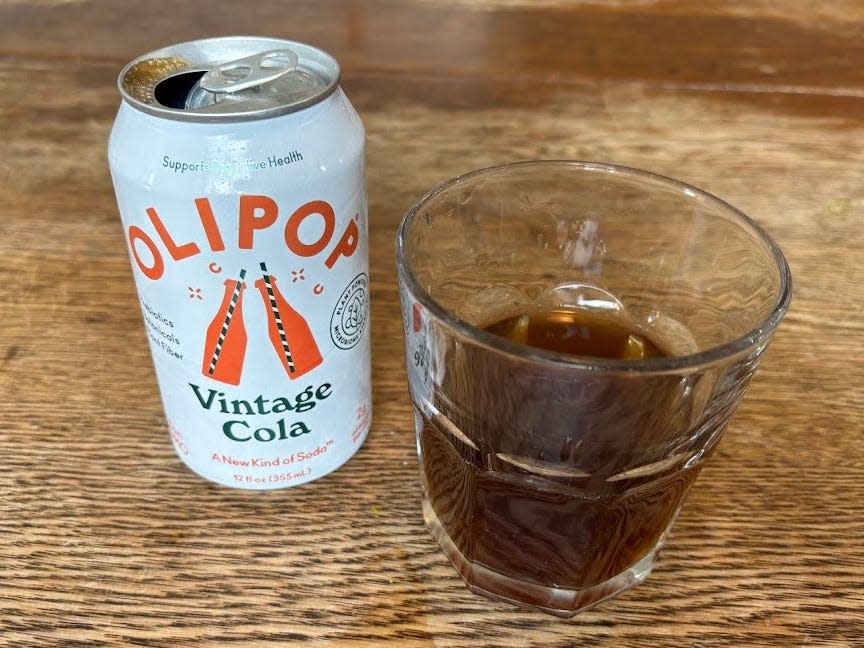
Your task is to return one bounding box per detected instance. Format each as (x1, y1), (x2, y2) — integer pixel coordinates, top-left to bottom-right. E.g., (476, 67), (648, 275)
(396, 159), (792, 374)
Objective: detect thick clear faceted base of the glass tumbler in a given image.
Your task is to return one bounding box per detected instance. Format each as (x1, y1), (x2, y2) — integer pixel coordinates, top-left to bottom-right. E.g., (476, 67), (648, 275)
(423, 498), (665, 619)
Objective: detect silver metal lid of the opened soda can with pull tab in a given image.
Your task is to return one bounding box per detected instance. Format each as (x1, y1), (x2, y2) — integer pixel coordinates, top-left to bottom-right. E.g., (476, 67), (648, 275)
(118, 36), (339, 122)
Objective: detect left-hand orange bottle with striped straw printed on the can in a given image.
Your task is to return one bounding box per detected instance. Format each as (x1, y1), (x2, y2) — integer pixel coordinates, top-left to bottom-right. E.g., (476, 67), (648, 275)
(201, 270), (247, 385)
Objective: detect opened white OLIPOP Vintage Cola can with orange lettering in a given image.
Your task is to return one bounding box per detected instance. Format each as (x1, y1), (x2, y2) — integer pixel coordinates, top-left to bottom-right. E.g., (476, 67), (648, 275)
(108, 37), (371, 489)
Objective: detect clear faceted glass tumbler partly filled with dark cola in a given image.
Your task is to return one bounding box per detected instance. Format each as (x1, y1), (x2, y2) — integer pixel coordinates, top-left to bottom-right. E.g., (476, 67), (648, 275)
(397, 161), (791, 617)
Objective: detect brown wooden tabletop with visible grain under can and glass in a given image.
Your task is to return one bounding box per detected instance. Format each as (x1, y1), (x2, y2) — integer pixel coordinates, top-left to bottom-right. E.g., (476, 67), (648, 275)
(0, 0), (864, 648)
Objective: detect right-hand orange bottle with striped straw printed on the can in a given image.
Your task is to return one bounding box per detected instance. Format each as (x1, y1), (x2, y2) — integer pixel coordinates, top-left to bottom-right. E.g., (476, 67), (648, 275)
(255, 263), (322, 380)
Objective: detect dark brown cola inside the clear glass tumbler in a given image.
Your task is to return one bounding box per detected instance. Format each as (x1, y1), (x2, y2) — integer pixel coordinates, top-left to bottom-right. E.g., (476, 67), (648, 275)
(420, 309), (698, 607)
